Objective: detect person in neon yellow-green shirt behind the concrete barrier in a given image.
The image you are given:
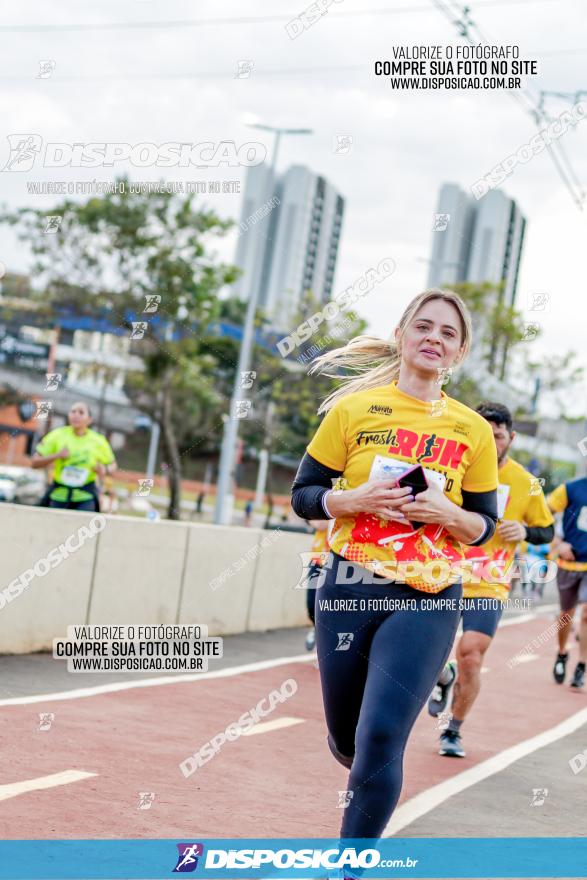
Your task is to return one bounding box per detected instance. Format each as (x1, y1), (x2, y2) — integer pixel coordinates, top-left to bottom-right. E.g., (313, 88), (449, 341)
(31, 403), (116, 511)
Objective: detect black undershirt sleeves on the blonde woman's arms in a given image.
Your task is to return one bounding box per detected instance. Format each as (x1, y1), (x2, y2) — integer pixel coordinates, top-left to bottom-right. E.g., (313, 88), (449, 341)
(291, 452), (497, 547)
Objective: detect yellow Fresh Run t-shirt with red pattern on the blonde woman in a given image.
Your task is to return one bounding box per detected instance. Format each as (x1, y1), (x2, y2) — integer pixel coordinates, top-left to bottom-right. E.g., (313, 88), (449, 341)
(307, 382), (497, 593)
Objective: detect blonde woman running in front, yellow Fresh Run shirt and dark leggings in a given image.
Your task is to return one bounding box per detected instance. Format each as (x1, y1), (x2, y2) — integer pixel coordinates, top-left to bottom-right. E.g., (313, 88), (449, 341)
(292, 289), (497, 838)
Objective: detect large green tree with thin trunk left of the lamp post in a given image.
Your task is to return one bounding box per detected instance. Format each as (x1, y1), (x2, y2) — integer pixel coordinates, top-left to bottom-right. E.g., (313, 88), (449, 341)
(0, 178), (238, 519)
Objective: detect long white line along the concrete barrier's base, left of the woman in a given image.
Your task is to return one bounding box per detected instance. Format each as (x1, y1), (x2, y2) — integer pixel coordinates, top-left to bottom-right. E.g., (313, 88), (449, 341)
(0, 654), (316, 707)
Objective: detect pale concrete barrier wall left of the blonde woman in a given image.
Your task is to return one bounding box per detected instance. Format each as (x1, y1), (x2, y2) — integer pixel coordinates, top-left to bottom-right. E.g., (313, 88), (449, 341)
(0, 504), (311, 654)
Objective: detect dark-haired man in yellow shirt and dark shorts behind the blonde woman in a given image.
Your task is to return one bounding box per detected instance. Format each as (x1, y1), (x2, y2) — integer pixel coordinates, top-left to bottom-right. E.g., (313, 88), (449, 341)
(428, 403), (554, 758)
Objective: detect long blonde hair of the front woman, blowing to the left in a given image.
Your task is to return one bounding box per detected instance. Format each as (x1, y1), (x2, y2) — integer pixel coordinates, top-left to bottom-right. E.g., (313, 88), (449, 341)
(309, 287), (473, 413)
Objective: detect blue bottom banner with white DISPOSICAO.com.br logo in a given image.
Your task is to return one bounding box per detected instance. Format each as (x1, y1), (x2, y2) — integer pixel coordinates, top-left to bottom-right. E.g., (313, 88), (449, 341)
(0, 835), (587, 880)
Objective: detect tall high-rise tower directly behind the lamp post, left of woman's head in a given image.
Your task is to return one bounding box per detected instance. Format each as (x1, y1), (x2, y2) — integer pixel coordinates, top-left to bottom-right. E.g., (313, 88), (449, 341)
(235, 165), (344, 329)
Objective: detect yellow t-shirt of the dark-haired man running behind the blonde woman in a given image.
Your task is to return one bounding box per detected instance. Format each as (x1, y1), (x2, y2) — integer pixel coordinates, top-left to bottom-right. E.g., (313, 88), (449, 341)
(463, 458), (554, 601)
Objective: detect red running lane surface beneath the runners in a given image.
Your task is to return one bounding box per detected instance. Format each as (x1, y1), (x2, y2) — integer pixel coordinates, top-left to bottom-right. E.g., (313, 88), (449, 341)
(0, 618), (586, 839)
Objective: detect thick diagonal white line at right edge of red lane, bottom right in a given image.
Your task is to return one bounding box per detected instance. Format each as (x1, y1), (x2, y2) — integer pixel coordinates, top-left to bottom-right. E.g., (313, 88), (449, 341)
(383, 709), (587, 837)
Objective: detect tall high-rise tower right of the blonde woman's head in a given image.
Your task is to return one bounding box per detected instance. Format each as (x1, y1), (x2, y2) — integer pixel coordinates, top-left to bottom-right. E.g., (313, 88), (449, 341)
(428, 183), (526, 378)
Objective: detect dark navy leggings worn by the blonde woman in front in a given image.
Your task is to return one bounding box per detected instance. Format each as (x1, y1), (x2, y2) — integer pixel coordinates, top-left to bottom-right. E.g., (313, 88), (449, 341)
(316, 554), (462, 838)
